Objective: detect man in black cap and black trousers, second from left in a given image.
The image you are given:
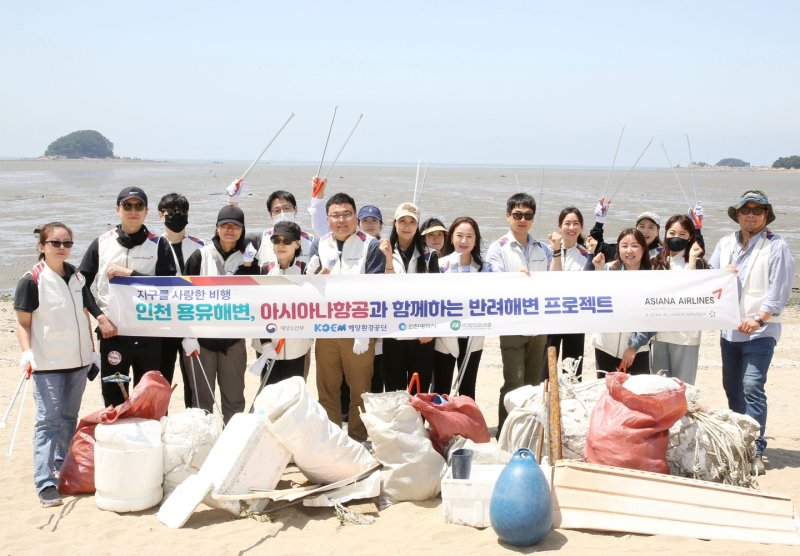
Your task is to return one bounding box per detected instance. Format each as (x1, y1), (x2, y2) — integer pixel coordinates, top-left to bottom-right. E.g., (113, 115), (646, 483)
(78, 187), (176, 405)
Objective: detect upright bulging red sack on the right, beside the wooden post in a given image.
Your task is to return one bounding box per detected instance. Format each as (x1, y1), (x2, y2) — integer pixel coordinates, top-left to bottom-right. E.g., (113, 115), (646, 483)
(583, 373), (686, 475)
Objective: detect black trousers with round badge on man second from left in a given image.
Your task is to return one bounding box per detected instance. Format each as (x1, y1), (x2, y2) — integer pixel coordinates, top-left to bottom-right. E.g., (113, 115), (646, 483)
(100, 336), (161, 406)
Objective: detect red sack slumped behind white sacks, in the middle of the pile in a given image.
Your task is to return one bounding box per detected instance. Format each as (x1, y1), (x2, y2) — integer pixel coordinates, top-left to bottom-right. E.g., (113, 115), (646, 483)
(408, 394), (490, 455)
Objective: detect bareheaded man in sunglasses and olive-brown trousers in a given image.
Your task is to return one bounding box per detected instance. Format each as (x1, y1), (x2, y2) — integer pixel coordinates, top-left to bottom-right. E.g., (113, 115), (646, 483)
(486, 193), (561, 436)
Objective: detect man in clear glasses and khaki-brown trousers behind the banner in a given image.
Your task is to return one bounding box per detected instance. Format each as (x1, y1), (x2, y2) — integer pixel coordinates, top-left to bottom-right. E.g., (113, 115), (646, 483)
(309, 193), (387, 442)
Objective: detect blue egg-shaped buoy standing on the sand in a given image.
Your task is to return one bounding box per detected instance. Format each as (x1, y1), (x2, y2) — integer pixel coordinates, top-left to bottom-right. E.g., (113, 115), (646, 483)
(489, 448), (553, 546)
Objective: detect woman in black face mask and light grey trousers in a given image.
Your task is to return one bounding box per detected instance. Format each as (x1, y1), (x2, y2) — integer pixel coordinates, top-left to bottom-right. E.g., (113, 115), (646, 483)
(650, 214), (707, 384)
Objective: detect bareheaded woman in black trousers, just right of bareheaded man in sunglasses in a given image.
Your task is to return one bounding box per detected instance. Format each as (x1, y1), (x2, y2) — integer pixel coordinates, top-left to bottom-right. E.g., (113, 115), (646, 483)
(542, 207), (592, 378)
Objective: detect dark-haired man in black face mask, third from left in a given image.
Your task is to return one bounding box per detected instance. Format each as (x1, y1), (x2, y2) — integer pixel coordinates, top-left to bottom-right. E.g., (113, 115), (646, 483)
(158, 193), (205, 407)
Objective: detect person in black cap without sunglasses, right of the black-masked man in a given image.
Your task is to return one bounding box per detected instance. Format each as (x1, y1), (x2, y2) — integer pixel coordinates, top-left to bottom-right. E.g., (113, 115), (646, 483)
(183, 205), (259, 423)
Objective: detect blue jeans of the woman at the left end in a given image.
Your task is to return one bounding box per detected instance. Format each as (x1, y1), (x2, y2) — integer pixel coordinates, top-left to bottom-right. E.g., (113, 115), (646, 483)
(32, 367), (89, 492)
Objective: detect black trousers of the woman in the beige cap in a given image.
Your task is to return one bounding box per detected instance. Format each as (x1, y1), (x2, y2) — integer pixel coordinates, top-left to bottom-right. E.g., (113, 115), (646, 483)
(383, 338), (434, 392)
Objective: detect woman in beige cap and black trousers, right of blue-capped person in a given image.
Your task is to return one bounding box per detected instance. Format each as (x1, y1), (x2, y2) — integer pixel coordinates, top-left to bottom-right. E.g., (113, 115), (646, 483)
(380, 203), (439, 392)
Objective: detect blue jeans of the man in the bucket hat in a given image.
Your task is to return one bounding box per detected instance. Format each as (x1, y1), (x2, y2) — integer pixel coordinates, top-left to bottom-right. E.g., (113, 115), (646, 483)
(719, 337), (777, 454)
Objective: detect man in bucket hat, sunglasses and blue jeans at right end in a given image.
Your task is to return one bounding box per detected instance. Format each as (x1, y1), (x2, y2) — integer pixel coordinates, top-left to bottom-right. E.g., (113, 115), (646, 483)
(708, 190), (794, 475)
